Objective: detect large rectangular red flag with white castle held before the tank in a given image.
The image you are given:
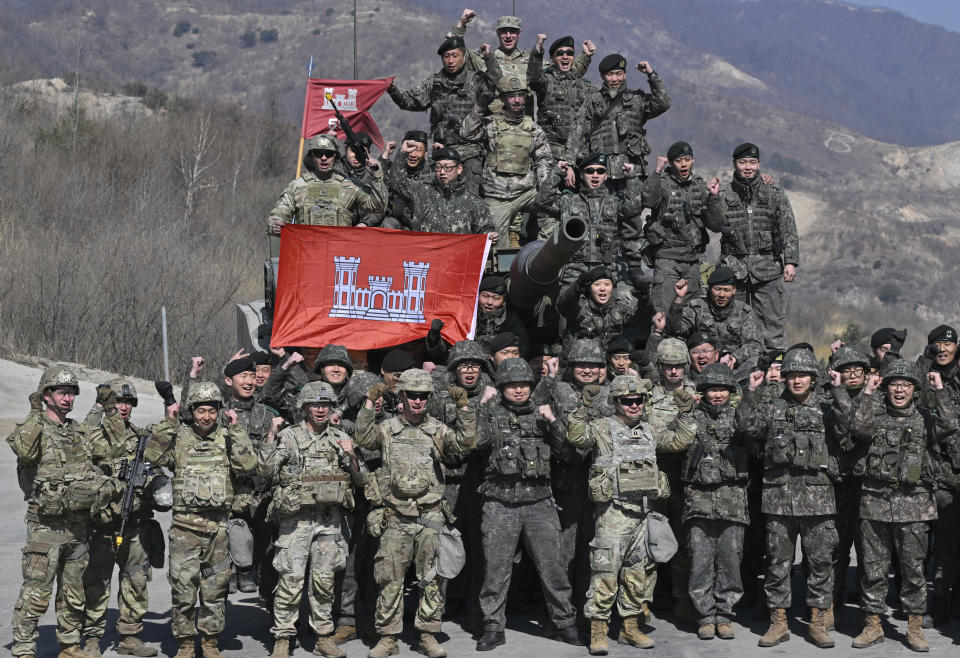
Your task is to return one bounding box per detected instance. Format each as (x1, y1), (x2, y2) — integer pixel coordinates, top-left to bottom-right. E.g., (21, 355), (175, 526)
(270, 224), (489, 350)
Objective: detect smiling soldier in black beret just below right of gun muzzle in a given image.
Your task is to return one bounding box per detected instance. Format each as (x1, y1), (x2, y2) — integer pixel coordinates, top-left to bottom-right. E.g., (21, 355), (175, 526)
(557, 265), (637, 348)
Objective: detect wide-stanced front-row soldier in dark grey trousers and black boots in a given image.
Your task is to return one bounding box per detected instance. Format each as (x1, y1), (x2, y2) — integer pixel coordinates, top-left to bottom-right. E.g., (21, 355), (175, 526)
(477, 358), (580, 651)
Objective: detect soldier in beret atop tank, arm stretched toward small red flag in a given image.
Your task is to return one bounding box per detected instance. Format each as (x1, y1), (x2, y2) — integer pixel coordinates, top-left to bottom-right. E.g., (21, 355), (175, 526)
(387, 34), (500, 195)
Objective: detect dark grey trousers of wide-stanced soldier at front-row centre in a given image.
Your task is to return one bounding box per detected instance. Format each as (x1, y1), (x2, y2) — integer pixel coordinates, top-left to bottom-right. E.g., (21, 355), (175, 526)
(480, 498), (576, 631)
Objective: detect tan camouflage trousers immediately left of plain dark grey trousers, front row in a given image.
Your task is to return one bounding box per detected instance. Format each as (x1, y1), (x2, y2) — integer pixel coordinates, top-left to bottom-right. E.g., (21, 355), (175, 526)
(373, 506), (444, 635)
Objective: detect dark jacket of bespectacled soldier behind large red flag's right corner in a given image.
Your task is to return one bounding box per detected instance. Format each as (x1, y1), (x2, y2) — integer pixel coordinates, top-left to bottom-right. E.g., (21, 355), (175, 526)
(394, 169), (494, 234)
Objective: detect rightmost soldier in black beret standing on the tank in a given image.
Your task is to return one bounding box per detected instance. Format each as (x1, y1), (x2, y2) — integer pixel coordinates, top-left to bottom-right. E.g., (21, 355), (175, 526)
(706, 143), (800, 350)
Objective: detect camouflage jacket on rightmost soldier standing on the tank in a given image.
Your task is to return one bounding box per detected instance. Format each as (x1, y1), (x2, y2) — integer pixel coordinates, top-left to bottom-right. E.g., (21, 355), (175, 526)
(706, 174), (800, 283)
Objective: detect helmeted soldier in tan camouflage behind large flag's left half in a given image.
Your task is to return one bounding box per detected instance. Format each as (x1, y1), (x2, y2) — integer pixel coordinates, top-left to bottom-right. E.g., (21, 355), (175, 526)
(267, 135), (387, 235)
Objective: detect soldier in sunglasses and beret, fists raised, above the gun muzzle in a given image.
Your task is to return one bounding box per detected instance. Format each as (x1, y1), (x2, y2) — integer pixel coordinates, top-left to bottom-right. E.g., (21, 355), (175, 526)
(537, 152), (643, 285)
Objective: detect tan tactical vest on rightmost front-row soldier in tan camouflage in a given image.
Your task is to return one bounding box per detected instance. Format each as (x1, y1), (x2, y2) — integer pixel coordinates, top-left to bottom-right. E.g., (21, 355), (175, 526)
(588, 418), (660, 504)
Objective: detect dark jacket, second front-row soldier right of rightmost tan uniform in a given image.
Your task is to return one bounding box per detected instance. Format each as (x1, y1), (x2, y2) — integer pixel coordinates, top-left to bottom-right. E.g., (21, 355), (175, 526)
(736, 390), (840, 516)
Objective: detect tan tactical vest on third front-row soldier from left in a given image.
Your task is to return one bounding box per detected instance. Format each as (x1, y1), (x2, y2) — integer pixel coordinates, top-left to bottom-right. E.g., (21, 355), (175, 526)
(173, 427), (233, 513)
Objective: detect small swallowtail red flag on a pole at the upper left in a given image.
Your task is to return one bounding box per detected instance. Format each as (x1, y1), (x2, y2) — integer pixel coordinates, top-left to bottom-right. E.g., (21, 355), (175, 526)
(300, 78), (393, 150)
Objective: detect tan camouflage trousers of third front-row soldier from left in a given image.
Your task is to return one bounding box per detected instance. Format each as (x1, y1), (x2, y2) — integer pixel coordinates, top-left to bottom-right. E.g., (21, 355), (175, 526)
(167, 514), (230, 639)
